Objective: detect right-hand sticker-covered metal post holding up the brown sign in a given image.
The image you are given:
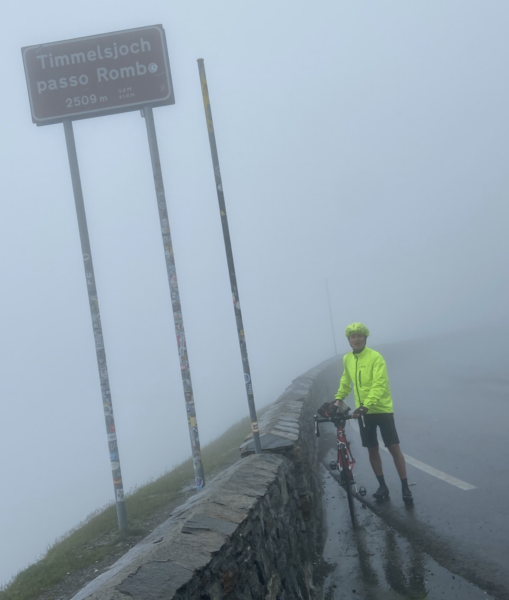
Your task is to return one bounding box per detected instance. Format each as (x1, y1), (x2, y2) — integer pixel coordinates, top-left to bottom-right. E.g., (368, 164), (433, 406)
(142, 106), (205, 490)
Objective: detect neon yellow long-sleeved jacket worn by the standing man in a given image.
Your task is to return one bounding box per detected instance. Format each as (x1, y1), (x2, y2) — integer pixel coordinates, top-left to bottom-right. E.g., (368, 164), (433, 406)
(336, 348), (393, 414)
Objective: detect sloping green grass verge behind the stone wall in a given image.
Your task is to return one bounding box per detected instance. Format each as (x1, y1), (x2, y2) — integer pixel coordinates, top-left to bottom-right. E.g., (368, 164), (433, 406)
(0, 411), (252, 600)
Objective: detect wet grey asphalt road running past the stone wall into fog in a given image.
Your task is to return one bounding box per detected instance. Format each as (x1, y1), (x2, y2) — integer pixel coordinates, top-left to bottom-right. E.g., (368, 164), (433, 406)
(320, 337), (509, 600)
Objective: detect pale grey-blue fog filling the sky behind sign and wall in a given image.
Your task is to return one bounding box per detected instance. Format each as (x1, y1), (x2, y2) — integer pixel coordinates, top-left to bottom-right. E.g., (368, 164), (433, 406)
(0, 0), (509, 582)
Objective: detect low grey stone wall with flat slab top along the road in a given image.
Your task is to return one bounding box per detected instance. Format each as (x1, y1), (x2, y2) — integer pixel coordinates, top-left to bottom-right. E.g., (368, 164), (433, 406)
(73, 360), (339, 600)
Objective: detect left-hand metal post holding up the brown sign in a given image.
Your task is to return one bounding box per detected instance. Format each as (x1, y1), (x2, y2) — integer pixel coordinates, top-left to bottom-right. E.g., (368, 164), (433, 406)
(64, 120), (127, 531)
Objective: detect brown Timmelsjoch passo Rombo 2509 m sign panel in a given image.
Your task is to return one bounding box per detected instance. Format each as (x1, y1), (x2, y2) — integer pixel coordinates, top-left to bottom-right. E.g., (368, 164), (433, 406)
(21, 25), (175, 125)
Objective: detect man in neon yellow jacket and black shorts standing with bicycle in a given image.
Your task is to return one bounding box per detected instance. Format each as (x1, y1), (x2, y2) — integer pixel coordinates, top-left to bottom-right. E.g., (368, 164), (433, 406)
(335, 323), (413, 504)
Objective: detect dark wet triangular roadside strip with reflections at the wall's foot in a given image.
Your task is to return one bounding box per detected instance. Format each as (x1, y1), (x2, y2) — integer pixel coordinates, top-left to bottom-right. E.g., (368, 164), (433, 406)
(322, 467), (492, 600)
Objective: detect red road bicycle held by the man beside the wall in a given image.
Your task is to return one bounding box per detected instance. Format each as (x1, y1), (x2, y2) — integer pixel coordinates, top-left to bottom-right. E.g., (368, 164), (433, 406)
(314, 404), (366, 529)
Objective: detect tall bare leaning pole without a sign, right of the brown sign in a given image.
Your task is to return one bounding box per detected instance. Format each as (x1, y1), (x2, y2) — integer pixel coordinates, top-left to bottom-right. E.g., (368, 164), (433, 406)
(198, 58), (262, 454)
